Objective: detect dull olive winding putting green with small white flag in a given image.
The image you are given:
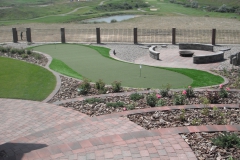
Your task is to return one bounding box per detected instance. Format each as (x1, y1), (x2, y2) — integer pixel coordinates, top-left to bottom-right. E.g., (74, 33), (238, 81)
(34, 44), (192, 88)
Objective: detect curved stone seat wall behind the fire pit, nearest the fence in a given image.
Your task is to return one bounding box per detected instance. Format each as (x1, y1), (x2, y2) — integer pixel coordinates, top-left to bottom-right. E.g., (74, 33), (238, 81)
(179, 43), (213, 52)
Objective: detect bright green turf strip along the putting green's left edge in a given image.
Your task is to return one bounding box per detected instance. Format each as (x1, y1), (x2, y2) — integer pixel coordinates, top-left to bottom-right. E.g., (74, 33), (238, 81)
(49, 58), (83, 79)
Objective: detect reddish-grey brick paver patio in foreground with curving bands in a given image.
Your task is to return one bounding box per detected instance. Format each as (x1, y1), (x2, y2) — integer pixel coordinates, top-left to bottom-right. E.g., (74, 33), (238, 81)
(0, 99), (240, 160)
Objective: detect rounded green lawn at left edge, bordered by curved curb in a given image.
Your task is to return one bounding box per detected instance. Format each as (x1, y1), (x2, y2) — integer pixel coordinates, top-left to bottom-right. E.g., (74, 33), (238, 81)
(0, 57), (56, 101)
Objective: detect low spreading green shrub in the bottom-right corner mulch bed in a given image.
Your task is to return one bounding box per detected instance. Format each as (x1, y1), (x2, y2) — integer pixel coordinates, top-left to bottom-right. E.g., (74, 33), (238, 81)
(212, 133), (240, 148)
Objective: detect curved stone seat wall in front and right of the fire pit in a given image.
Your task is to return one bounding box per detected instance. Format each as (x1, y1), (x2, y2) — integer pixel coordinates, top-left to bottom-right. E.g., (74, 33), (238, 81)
(193, 51), (224, 64)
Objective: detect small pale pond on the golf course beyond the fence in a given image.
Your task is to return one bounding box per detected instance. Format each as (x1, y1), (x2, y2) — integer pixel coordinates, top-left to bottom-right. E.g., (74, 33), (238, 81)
(84, 15), (136, 23)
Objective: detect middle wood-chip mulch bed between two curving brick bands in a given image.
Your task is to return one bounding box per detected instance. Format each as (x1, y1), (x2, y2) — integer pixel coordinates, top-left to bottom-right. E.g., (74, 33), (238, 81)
(128, 107), (240, 130)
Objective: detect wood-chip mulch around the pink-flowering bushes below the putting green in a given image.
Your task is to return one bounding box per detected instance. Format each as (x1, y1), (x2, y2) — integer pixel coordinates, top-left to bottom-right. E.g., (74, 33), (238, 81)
(60, 91), (240, 117)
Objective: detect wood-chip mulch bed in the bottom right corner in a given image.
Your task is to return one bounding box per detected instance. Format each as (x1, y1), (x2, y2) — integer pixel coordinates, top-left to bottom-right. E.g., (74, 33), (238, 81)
(181, 132), (240, 160)
